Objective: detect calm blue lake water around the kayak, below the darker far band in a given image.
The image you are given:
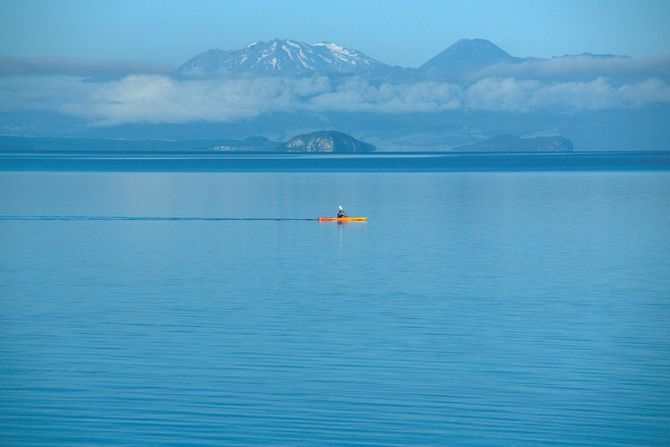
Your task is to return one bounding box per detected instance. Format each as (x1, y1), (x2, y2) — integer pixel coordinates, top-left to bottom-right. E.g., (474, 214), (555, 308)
(0, 172), (670, 446)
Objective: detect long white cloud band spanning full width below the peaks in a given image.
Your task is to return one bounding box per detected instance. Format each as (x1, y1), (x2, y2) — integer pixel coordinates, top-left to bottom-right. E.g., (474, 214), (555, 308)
(0, 74), (670, 126)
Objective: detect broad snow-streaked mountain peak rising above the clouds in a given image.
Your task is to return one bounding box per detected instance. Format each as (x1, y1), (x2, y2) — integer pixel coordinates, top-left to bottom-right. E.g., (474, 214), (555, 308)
(179, 39), (390, 76)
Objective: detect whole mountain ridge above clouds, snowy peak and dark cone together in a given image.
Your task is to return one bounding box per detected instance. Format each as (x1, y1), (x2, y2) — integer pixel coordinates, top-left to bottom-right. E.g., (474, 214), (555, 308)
(176, 38), (628, 84)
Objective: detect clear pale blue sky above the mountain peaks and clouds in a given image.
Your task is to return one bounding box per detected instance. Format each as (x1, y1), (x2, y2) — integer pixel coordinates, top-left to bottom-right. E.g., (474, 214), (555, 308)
(0, 0), (670, 66)
